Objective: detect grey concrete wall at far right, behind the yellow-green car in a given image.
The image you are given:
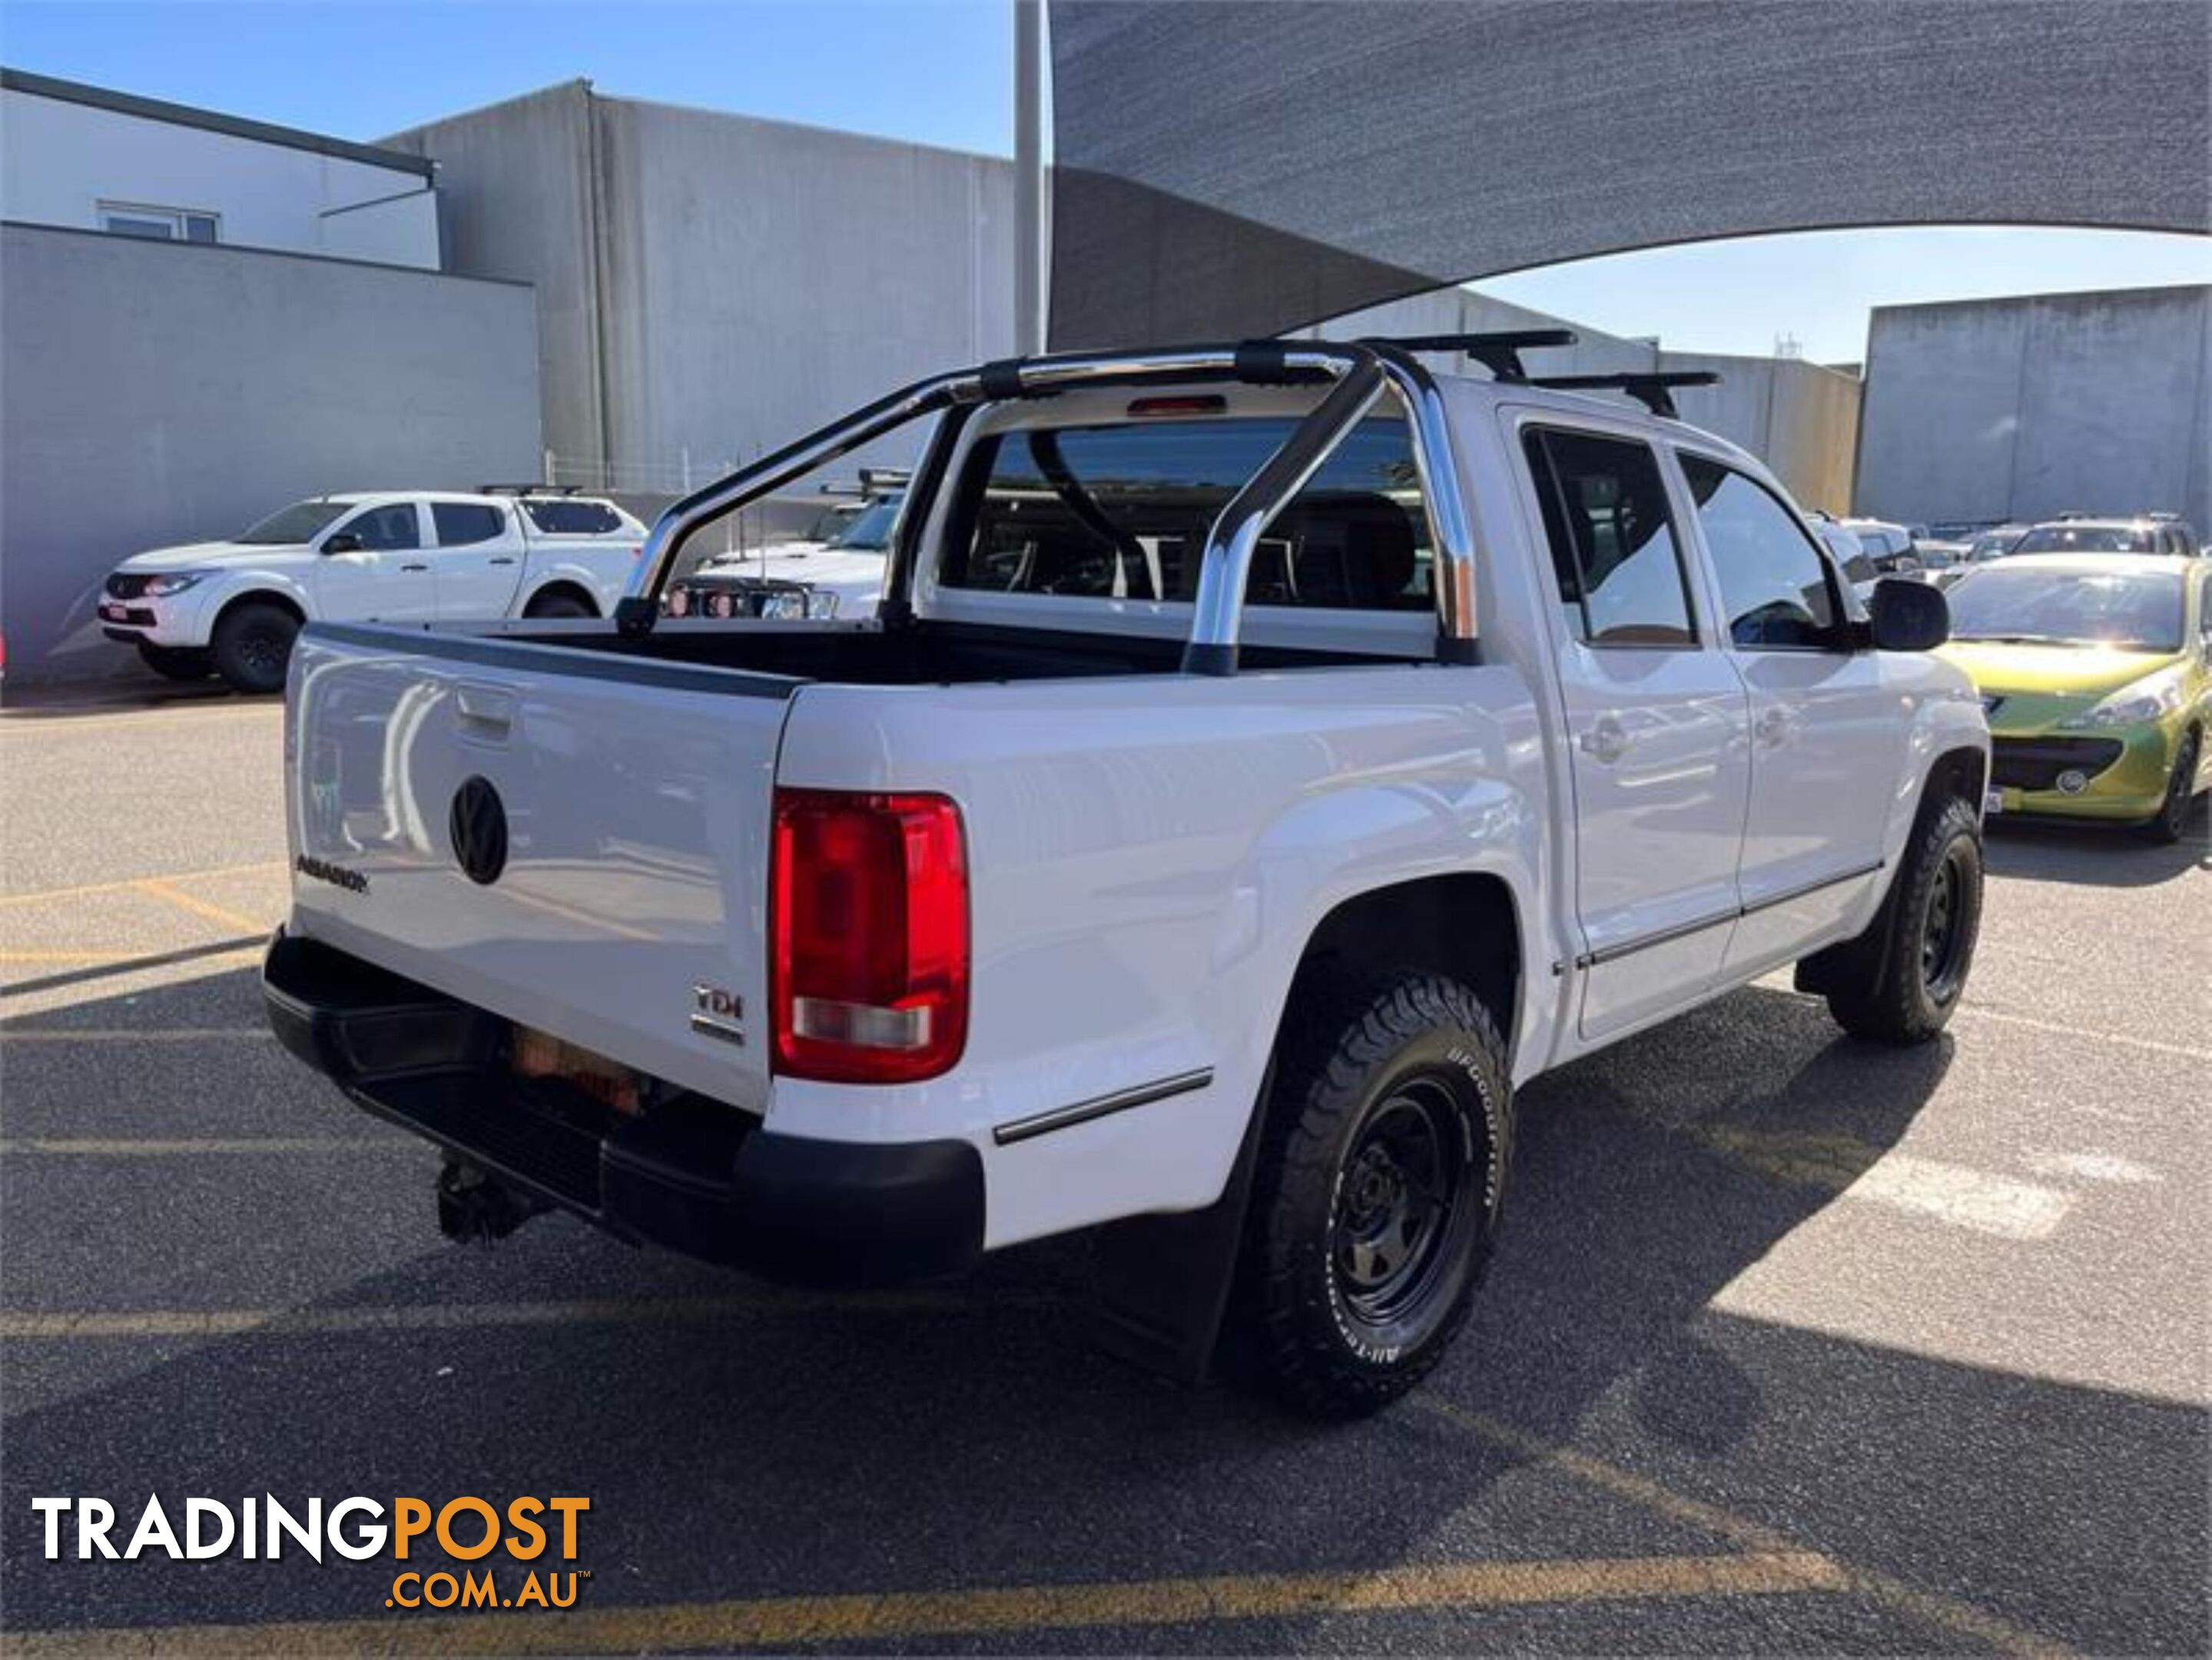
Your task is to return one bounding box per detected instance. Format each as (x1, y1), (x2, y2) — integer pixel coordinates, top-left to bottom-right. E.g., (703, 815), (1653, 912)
(1858, 287), (2212, 533)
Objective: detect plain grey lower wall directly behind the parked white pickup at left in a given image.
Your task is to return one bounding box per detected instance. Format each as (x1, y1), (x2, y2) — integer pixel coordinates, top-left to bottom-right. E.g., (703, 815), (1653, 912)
(0, 224), (539, 677)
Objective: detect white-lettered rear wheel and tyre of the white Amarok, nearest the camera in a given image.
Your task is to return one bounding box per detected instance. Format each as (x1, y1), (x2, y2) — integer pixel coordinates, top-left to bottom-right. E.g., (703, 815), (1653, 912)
(1230, 974), (1513, 1419)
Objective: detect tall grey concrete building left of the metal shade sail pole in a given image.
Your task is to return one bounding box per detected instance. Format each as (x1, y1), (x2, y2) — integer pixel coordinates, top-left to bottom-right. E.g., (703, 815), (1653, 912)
(383, 82), (1013, 500)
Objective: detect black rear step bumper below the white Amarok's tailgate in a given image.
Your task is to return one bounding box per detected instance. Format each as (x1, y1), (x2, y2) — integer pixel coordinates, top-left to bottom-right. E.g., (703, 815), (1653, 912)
(261, 934), (984, 1283)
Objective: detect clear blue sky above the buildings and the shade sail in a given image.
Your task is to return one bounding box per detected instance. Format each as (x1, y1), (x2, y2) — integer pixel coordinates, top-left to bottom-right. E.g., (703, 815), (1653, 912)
(0, 0), (2212, 360)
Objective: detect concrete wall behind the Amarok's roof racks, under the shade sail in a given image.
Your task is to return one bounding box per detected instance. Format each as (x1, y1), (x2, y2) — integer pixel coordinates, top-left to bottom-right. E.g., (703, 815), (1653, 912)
(1305, 287), (1860, 513)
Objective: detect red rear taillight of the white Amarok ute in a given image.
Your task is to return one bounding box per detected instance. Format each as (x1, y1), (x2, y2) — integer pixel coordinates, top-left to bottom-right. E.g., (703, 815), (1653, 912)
(774, 790), (969, 1084)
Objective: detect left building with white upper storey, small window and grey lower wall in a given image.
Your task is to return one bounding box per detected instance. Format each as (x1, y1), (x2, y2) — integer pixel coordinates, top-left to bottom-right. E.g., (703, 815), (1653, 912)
(0, 71), (542, 677)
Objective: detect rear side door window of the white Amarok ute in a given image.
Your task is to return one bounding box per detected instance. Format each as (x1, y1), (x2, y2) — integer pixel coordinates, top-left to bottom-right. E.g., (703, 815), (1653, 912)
(1522, 427), (1696, 646)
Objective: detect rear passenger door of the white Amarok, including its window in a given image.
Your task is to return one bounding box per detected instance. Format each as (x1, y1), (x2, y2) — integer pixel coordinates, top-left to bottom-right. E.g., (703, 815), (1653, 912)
(1520, 416), (1749, 1038)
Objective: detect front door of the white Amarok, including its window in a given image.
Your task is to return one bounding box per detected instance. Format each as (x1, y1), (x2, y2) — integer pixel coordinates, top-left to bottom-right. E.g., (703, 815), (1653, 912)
(1676, 450), (1909, 976)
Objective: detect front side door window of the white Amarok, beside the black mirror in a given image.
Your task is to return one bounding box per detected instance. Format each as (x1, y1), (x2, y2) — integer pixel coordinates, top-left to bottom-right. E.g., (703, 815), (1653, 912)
(1681, 456), (1840, 651)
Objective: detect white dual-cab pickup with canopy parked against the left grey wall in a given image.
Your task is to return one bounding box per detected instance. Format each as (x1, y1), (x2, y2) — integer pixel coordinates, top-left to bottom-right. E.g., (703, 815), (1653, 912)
(98, 487), (646, 692)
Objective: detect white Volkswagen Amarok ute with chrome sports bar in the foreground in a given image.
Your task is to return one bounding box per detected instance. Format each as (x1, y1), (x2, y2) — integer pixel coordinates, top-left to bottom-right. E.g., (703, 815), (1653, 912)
(264, 332), (1988, 1414)
